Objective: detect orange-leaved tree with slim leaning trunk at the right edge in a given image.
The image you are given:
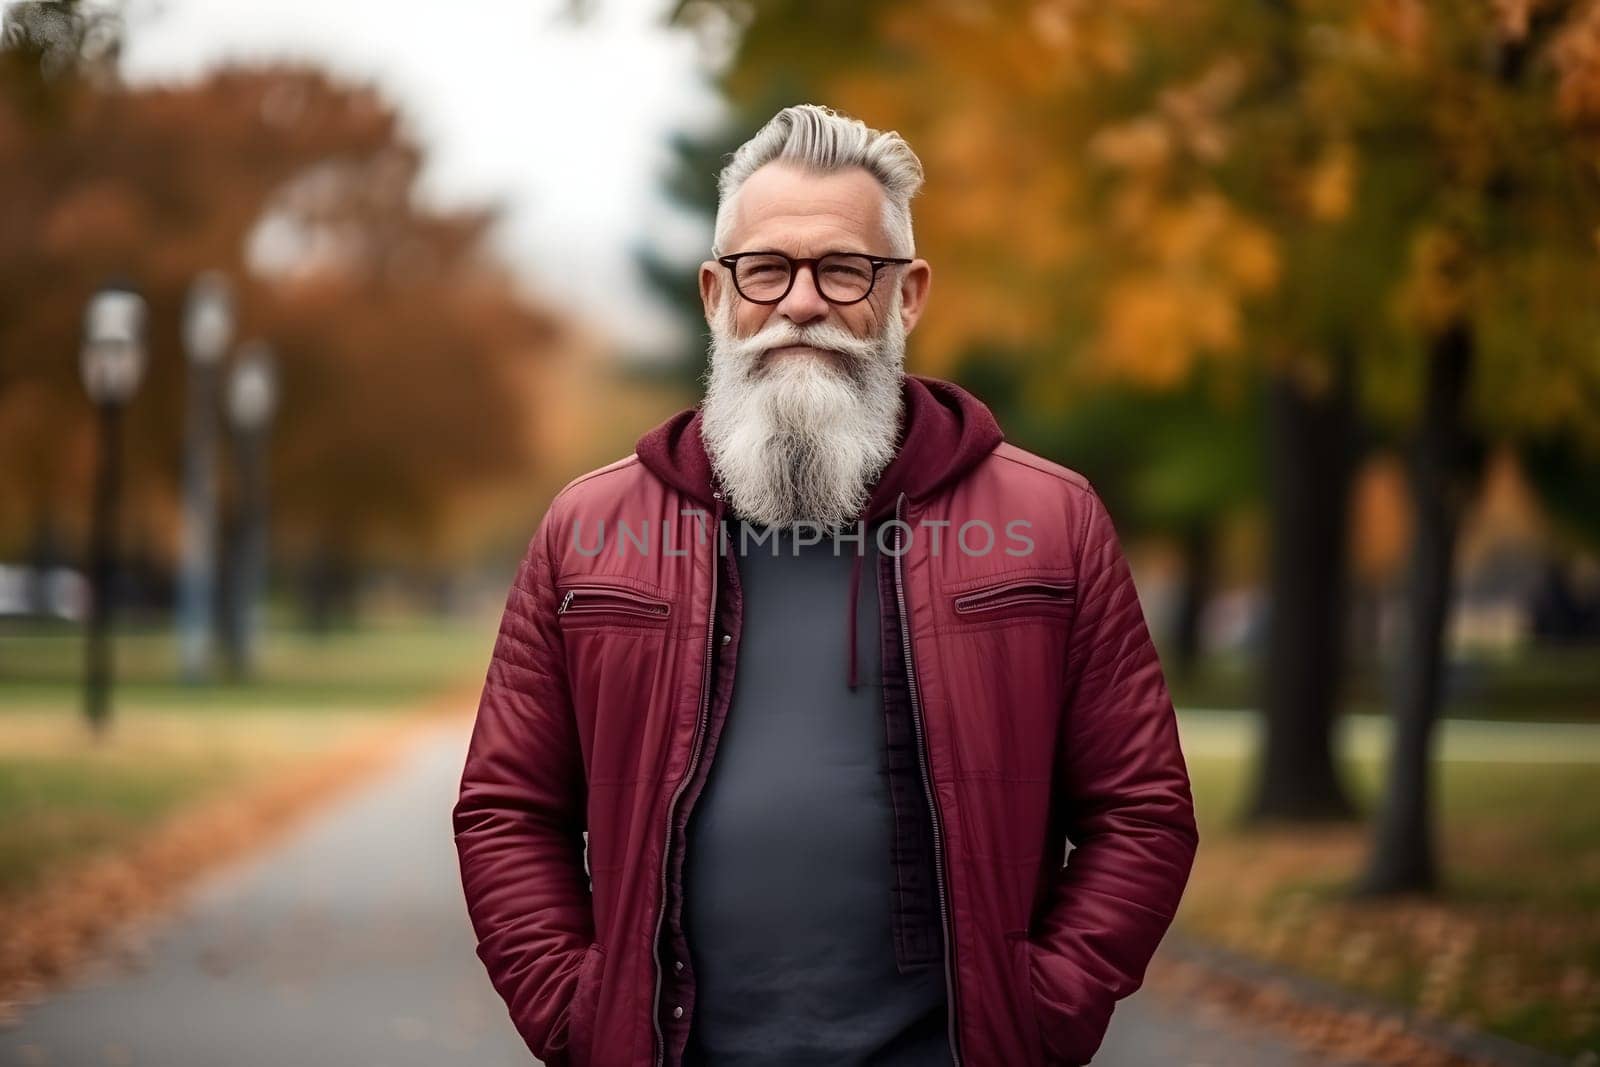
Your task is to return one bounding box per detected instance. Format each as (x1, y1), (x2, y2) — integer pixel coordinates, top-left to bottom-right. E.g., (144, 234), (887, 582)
(1355, 0), (1600, 893)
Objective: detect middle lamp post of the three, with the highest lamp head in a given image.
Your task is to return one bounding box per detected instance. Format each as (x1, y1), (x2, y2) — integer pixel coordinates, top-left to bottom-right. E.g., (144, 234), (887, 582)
(178, 270), (234, 681)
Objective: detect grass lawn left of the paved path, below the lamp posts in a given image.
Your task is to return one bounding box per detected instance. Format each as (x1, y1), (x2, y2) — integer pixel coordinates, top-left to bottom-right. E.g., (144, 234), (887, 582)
(0, 617), (494, 904)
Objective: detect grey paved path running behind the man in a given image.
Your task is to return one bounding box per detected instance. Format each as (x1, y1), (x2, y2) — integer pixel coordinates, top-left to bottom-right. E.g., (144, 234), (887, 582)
(0, 723), (1376, 1067)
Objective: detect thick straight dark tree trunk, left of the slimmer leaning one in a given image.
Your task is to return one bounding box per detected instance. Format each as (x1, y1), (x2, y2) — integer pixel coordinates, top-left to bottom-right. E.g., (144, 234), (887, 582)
(1243, 354), (1355, 822)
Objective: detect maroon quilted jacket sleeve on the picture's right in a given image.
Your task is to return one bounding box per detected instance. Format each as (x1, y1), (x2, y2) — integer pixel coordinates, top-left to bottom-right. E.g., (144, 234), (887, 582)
(1030, 488), (1198, 1064)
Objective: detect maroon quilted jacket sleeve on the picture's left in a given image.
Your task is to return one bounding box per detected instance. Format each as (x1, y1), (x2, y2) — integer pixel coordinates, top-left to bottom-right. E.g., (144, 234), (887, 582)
(451, 512), (594, 1067)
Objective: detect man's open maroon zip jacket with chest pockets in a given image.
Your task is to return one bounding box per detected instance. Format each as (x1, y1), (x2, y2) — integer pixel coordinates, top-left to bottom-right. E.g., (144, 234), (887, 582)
(453, 376), (1198, 1067)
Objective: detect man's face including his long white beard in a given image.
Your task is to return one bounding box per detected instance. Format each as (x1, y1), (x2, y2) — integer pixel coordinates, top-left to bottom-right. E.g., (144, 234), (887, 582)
(701, 165), (930, 525)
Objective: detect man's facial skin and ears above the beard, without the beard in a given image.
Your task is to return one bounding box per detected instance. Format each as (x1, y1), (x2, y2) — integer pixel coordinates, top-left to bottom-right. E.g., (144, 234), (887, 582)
(699, 163), (933, 374)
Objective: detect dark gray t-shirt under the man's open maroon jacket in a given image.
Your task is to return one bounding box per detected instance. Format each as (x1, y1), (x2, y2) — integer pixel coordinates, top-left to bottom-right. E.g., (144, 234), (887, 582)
(683, 522), (950, 1067)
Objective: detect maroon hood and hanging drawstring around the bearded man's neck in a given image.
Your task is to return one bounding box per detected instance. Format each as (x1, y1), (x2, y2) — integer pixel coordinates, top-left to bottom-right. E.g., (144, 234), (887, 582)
(635, 374), (1003, 689)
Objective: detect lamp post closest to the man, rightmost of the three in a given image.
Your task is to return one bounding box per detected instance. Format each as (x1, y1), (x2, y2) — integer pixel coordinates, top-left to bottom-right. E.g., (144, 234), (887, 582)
(227, 341), (278, 678)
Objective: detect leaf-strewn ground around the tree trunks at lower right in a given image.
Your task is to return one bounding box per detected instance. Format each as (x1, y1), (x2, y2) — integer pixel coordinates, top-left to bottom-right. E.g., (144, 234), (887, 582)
(1178, 821), (1600, 1064)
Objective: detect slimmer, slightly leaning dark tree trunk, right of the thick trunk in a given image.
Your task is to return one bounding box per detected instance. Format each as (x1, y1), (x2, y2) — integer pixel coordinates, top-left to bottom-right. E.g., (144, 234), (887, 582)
(1357, 322), (1474, 894)
